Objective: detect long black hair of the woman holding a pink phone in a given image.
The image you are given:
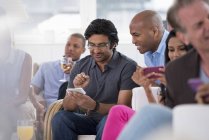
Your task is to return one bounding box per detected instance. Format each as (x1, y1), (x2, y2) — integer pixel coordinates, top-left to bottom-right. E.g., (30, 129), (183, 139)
(165, 30), (192, 64)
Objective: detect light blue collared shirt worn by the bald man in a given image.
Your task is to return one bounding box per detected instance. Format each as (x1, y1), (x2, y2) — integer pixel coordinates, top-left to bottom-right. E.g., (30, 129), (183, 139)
(144, 30), (168, 67)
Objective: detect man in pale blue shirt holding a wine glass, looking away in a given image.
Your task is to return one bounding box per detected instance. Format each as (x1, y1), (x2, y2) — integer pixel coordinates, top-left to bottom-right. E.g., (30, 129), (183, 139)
(29, 33), (85, 137)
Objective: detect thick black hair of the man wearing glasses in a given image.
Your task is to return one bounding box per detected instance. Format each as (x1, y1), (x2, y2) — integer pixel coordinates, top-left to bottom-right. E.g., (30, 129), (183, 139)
(84, 19), (119, 47)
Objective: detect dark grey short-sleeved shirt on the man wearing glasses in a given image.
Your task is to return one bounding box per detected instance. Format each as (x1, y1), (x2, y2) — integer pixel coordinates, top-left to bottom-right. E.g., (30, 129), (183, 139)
(68, 51), (138, 121)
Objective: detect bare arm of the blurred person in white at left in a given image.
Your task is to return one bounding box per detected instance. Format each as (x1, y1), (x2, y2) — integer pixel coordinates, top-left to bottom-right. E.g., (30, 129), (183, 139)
(13, 53), (32, 106)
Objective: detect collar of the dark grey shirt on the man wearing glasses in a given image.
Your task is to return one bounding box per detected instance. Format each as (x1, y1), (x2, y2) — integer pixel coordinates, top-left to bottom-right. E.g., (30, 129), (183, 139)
(91, 51), (119, 68)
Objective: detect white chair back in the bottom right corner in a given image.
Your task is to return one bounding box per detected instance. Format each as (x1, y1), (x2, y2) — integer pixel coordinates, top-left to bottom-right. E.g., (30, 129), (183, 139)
(172, 104), (209, 140)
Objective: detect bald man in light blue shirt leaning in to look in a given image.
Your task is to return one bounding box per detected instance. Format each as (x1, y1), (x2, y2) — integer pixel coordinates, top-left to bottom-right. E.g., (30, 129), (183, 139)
(129, 10), (168, 67)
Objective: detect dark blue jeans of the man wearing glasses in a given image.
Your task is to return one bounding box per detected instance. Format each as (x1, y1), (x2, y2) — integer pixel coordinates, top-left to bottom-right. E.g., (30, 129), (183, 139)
(52, 110), (106, 140)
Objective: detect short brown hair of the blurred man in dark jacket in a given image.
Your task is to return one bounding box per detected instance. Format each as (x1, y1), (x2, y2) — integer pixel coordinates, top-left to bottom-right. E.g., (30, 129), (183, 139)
(167, 0), (209, 32)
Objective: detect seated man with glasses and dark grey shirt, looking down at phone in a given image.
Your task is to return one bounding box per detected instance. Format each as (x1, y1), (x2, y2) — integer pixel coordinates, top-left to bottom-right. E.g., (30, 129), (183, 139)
(52, 19), (137, 140)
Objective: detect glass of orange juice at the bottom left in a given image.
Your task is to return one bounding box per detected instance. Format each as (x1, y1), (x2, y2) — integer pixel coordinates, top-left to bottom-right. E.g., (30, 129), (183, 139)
(17, 120), (34, 140)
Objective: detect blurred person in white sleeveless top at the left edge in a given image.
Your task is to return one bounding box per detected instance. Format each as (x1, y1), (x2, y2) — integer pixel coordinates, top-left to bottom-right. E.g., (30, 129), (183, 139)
(0, 8), (35, 140)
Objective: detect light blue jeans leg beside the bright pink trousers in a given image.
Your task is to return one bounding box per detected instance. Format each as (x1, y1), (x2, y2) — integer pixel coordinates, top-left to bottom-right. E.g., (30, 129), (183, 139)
(118, 104), (172, 140)
